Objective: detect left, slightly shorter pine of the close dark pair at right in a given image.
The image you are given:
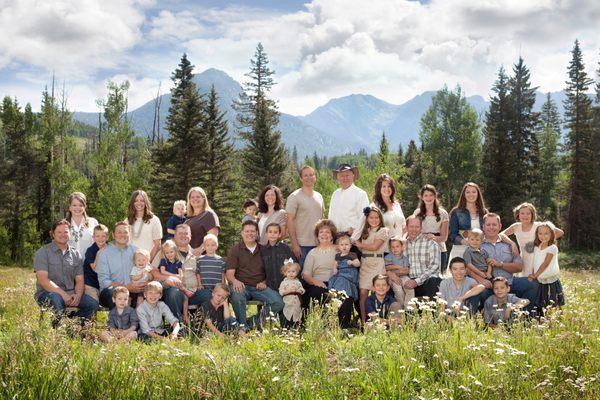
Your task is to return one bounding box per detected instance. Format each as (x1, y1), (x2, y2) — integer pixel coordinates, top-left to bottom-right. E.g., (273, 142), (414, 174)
(481, 67), (514, 221)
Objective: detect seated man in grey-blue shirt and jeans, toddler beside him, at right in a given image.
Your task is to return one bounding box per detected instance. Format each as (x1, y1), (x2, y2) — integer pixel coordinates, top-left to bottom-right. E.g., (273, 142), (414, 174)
(475, 213), (538, 311)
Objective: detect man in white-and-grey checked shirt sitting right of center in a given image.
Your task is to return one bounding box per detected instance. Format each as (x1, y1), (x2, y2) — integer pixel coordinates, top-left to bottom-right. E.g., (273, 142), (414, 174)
(400, 215), (441, 298)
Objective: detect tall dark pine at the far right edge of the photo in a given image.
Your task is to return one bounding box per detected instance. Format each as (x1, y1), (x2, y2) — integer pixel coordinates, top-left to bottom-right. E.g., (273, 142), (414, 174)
(564, 40), (600, 249)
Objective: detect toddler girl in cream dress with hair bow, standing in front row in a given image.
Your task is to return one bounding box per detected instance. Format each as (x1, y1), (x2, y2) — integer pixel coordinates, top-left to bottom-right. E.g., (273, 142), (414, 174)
(279, 258), (304, 328)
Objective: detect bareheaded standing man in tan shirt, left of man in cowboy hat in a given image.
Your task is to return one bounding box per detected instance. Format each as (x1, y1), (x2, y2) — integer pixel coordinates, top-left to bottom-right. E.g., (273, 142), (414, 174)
(285, 165), (324, 265)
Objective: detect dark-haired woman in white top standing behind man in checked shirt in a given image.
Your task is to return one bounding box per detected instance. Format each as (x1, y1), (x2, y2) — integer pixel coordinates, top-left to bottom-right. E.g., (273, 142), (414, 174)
(413, 185), (449, 273)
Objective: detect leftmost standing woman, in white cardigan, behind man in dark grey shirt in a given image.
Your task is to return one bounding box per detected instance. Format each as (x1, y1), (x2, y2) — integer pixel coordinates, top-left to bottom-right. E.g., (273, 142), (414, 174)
(65, 192), (98, 257)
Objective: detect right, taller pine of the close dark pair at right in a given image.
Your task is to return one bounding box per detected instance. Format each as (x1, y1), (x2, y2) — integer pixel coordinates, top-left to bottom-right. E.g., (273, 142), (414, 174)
(504, 57), (540, 206)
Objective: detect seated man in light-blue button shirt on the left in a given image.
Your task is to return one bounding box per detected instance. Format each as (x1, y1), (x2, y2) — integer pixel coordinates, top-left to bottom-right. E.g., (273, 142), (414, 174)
(96, 221), (146, 309)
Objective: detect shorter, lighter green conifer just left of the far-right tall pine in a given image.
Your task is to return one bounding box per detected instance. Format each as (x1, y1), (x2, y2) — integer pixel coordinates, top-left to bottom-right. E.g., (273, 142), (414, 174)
(533, 93), (561, 221)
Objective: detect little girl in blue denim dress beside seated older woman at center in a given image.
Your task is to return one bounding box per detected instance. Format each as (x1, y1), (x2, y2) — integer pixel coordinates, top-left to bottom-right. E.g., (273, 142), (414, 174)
(327, 235), (360, 329)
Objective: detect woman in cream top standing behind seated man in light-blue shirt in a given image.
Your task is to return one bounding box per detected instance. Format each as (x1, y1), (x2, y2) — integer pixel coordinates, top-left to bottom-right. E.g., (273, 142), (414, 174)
(127, 190), (162, 262)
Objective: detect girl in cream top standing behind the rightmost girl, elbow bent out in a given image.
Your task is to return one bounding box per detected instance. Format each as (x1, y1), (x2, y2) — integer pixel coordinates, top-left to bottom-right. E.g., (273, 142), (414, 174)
(502, 203), (564, 277)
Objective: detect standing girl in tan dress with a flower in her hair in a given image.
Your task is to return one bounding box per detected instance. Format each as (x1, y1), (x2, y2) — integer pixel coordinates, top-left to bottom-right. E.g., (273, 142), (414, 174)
(355, 207), (388, 323)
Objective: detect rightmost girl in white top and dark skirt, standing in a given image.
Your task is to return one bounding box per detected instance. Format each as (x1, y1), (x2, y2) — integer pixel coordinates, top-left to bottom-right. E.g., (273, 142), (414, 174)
(527, 222), (565, 308)
